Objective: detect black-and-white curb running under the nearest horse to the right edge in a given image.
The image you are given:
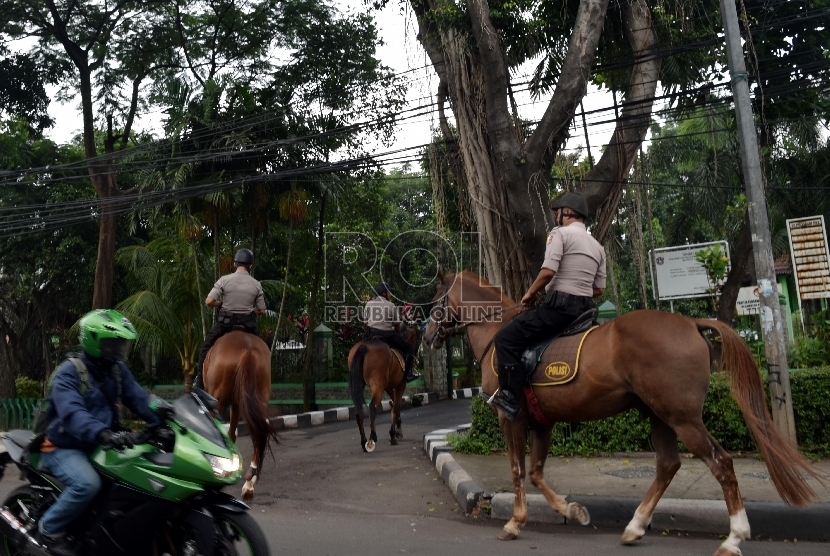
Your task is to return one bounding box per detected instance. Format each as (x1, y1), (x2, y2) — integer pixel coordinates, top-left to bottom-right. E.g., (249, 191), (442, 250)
(424, 424), (830, 542)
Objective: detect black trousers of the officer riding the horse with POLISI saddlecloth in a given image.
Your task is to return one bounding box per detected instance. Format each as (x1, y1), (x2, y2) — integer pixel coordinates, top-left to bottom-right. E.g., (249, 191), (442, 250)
(495, 292), (593, 396)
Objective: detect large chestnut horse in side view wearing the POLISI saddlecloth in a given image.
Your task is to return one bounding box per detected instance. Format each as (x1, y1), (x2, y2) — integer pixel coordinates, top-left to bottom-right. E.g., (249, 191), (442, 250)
(424, 271), (818, 556)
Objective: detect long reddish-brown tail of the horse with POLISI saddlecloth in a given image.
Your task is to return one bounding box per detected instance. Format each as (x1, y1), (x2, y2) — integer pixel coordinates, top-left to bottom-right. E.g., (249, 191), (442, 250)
(695, 319), (823, 506)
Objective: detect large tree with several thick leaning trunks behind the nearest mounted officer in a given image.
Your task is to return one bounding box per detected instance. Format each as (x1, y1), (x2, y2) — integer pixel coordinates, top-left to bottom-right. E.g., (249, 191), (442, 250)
(411, 0), (676, 296)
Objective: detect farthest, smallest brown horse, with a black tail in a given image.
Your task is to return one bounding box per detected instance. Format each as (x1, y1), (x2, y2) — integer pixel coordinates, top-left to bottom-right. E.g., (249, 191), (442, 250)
(348, 327), (421, 452)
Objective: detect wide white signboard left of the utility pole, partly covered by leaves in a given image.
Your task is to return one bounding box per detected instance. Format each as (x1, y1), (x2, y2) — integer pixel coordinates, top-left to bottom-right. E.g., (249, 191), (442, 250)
(649, 241), (729, 299)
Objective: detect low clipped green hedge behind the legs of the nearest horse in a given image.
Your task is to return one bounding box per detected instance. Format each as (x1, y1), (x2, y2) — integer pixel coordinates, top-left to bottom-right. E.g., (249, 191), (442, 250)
(450, 367), (830, 457)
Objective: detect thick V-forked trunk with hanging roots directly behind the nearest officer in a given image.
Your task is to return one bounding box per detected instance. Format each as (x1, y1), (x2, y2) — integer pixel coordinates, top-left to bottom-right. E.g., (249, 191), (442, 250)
(411, 0), (608, 299)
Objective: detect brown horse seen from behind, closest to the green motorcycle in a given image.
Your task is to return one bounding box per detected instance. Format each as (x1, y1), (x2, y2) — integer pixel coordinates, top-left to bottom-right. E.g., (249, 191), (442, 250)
(202, 330), (278, 501)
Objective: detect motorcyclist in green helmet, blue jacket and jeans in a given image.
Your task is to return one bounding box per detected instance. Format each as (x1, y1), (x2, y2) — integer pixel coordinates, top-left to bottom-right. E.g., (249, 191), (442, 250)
(38, 309), (173, 556)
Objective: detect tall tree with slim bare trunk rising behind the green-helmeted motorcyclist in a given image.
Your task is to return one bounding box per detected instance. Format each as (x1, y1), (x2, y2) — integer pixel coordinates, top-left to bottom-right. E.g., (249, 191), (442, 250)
(0, 0), (182, 308)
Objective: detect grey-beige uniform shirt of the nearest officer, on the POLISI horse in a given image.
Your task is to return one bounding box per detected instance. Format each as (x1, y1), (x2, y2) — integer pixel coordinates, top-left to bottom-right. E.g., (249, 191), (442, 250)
(542, 222), (605, 297)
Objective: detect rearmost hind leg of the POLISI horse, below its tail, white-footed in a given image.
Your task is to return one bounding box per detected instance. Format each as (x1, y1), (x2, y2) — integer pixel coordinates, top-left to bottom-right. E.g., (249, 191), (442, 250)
(675, 421), (750, 556)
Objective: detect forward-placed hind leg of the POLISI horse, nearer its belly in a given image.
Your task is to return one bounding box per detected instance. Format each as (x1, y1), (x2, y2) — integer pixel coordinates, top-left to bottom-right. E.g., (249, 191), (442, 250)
(622, 415), (680, 544)
